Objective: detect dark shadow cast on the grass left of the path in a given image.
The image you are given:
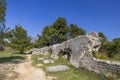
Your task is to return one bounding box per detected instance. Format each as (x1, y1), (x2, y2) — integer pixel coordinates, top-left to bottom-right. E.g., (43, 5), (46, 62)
(0, 56), (25, 63)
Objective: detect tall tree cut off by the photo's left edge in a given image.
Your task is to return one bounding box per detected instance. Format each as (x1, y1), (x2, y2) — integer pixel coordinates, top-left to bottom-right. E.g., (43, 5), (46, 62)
(0, 0), (6, 45)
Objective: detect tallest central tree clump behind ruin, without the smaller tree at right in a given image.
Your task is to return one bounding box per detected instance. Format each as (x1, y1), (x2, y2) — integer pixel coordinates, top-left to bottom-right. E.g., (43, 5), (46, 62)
(36, 17), (69, 47)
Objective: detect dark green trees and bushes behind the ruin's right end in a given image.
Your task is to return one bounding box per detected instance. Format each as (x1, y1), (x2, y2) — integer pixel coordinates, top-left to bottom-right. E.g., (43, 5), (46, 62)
(98, 32), (120, 60)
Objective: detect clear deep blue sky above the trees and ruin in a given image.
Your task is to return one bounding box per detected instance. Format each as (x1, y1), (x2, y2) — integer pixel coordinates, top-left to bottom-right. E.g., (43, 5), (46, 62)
(6, 0), (120, 40)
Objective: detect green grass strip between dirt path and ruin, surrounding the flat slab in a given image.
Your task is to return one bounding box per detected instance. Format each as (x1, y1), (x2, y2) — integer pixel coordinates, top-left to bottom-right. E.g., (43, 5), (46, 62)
(32, 55), (107, 80)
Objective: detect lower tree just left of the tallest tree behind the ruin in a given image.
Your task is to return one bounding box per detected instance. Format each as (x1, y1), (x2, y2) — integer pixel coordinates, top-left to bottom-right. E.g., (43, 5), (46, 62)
(36, 26), (58, 47)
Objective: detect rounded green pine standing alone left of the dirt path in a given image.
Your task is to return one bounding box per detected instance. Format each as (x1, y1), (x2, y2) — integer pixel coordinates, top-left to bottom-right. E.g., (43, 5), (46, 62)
(9, 25), (31, 53)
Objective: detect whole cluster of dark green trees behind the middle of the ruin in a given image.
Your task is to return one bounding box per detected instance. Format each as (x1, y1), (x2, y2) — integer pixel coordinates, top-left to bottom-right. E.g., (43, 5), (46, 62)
(35, 17), (86, 47)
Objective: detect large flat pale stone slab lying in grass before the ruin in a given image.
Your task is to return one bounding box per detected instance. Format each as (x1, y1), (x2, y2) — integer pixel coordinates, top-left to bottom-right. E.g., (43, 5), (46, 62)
(46, 65), (70, 72)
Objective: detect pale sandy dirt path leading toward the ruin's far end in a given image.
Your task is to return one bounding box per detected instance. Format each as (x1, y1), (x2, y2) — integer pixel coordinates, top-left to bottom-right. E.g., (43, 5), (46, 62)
(15, 55), (48, 80)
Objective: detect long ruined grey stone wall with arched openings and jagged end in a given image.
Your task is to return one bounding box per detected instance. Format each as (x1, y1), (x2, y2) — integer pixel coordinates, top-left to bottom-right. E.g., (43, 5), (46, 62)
(31, 32), (120, 73)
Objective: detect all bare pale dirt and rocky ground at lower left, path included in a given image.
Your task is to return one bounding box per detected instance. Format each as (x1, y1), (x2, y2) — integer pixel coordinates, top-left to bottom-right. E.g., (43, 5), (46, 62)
(0, 55), (53, 80)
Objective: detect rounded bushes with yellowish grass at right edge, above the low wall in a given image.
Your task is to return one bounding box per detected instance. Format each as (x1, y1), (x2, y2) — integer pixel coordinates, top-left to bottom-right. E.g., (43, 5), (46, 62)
(93, 35), (120, 61)
